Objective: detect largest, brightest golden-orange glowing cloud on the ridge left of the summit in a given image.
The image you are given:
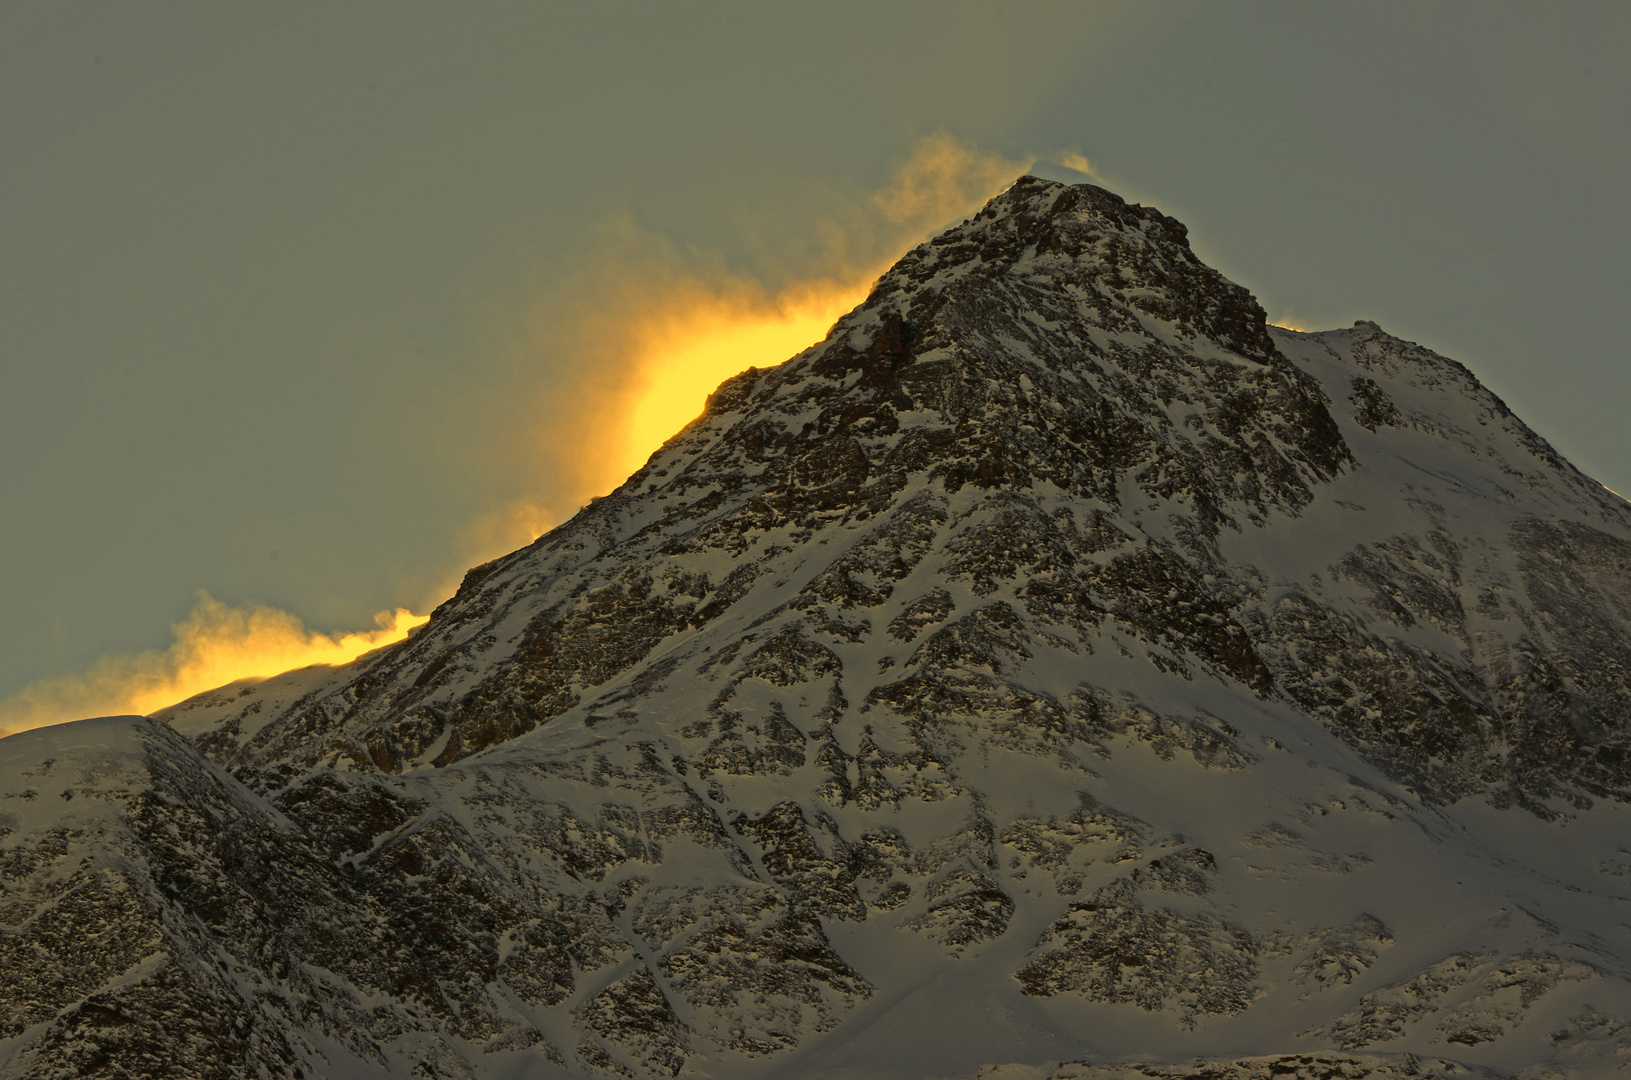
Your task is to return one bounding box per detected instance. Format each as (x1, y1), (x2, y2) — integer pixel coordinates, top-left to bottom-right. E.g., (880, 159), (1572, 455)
(499, 135), (1024, 502)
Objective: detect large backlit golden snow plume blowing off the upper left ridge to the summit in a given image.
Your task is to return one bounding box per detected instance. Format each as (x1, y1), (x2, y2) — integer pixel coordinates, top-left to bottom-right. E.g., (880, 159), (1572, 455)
(440, 134), (1024, 567)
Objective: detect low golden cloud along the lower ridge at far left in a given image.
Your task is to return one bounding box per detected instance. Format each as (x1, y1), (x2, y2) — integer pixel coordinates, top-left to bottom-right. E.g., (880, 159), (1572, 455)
(0, 592), (431, 734)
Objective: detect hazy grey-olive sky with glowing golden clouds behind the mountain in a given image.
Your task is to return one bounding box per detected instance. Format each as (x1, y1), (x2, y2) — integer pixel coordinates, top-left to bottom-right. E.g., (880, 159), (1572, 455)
(0, 0), (1631, 729)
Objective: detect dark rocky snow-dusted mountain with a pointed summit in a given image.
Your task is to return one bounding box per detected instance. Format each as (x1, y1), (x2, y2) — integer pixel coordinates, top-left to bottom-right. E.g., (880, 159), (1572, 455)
(9, 176), (1631, 1080)
